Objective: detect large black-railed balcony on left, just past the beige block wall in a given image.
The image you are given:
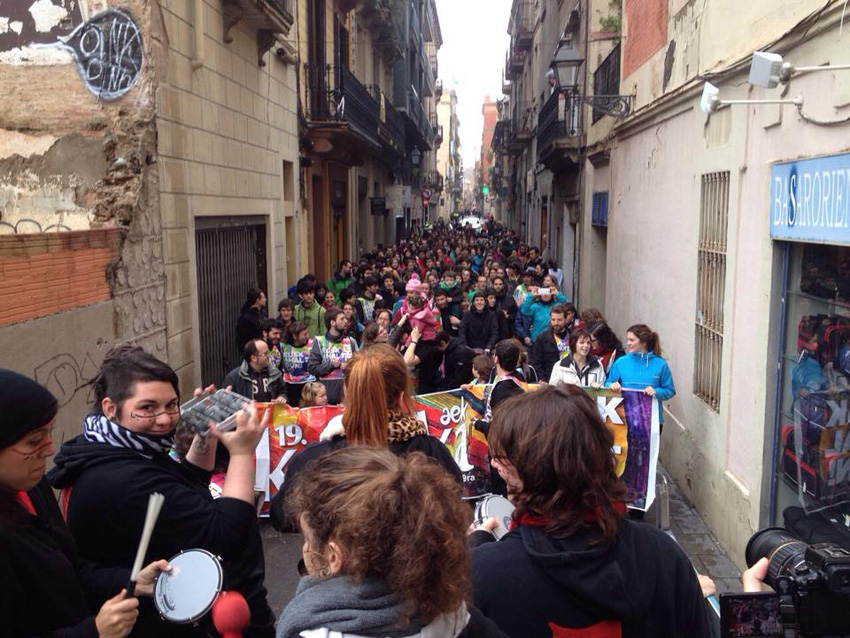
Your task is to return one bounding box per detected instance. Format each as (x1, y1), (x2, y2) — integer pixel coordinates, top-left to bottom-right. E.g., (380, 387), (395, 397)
(307, 66), (384, 166)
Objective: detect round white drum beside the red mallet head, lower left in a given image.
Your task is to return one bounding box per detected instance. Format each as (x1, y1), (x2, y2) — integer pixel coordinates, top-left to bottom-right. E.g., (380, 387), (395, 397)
(153, 549), (224, 625)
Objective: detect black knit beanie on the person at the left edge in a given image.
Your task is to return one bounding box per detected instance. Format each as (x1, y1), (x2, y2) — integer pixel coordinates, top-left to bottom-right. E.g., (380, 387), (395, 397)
(0, 369), (59, 450)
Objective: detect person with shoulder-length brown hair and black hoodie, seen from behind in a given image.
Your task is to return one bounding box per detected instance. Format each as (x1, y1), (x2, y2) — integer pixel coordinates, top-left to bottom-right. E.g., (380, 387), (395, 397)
(472, 385), (709, 638)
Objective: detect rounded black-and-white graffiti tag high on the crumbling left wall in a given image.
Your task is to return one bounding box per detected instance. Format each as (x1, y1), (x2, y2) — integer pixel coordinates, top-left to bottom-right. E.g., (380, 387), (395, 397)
(62, 9), (144, 100)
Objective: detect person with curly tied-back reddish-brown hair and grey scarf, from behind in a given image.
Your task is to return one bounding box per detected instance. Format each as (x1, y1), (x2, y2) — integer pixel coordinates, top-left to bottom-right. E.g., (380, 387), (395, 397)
(277, 446), (505, 638)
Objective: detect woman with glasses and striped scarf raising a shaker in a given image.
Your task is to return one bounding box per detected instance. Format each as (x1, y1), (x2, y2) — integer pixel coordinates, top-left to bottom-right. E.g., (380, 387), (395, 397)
(48, 346), (274, 638)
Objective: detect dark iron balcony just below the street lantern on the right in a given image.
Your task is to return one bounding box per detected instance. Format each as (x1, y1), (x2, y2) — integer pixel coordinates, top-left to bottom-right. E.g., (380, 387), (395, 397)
(537, 92), (583, 171)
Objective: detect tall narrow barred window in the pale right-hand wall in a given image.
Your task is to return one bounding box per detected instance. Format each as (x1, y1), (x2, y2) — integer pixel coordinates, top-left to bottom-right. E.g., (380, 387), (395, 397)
(694, 172), (729, 412)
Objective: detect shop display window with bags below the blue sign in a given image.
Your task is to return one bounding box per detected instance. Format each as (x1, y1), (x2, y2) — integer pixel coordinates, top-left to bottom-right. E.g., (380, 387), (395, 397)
(773, 244), (850, 549)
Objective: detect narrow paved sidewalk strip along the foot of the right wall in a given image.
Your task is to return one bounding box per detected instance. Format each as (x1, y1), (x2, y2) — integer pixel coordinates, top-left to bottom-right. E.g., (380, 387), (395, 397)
(647, 468), (741, 594)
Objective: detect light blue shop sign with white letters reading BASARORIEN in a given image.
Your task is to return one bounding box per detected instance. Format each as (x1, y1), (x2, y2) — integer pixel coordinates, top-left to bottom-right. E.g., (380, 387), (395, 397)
(770, 153), (850, 245)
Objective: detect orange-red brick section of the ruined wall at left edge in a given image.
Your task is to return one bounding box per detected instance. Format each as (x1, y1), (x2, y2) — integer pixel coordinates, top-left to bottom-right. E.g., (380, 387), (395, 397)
(0, 228), (120, 326)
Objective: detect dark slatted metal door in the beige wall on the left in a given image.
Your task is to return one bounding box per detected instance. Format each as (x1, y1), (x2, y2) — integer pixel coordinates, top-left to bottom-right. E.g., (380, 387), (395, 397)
(195, 217), (268, 386)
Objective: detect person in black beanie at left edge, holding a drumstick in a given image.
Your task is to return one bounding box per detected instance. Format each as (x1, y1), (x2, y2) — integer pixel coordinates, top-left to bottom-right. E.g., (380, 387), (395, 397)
(0, 370), (170, 638)
